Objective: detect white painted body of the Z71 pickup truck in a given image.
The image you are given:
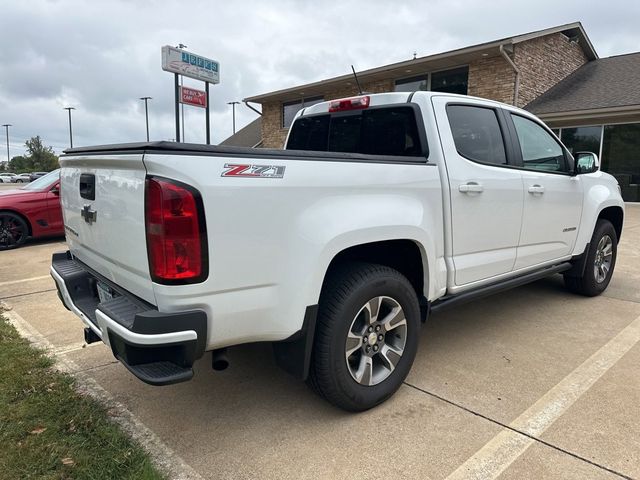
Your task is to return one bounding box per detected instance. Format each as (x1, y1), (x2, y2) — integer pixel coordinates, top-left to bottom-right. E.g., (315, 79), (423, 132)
(52, 92), (624, 408)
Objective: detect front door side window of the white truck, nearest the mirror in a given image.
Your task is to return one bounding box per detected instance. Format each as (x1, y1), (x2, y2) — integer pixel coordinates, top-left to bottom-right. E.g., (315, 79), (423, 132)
(511, 114), (568, 172)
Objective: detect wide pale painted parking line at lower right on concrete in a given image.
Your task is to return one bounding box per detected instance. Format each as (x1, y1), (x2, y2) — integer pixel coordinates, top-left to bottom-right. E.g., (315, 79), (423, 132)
(447, 317), (640, 480)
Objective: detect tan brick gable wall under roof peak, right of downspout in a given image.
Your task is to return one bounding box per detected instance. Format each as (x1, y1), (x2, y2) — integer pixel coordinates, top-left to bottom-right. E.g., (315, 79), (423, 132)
(512, 33), (587, 107)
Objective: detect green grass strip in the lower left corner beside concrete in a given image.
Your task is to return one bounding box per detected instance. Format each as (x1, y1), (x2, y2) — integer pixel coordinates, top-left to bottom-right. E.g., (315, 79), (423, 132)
(0, 313), (164, 480)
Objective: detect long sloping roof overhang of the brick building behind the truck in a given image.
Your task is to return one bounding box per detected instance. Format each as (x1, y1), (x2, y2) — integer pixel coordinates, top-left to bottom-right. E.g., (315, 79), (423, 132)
(243, 22), (598, 103)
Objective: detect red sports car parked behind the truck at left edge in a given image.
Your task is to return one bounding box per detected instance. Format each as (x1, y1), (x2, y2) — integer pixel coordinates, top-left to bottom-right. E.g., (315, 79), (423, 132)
(0, 170), (64, 250)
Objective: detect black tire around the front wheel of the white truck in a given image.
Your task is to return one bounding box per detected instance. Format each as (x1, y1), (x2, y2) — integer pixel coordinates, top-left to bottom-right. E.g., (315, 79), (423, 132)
(564, 219), (618, 297)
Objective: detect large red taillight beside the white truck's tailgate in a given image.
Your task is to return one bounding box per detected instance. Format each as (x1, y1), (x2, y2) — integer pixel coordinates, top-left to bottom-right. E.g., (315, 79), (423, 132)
(145, 177), (208, 285)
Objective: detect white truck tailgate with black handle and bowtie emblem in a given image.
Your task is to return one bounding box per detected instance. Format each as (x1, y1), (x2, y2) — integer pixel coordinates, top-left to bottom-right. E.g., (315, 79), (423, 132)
(60, 153), (155, 304)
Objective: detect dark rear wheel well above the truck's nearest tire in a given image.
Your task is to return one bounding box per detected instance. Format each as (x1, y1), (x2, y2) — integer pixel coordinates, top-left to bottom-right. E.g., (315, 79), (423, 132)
(328, 240), (424, 299)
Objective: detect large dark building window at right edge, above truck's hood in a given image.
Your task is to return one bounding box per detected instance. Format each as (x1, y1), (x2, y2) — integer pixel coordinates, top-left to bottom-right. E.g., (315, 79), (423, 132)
(600, 123), (640, 202)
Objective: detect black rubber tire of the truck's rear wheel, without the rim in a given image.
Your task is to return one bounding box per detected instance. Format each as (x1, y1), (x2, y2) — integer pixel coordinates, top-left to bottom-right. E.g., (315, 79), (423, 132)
(307, 263), (420, 412)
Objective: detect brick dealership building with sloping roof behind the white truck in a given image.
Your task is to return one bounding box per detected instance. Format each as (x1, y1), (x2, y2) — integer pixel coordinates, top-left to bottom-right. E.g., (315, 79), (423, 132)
(228, 22), (640, 202)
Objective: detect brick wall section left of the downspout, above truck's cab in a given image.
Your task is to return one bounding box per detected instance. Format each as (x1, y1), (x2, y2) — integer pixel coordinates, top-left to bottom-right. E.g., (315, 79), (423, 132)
(467, 56), (516, 104)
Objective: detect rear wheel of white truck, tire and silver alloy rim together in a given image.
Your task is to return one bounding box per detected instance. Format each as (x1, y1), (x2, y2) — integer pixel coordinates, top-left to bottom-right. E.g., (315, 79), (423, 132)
(308, 263), (420, 411)
